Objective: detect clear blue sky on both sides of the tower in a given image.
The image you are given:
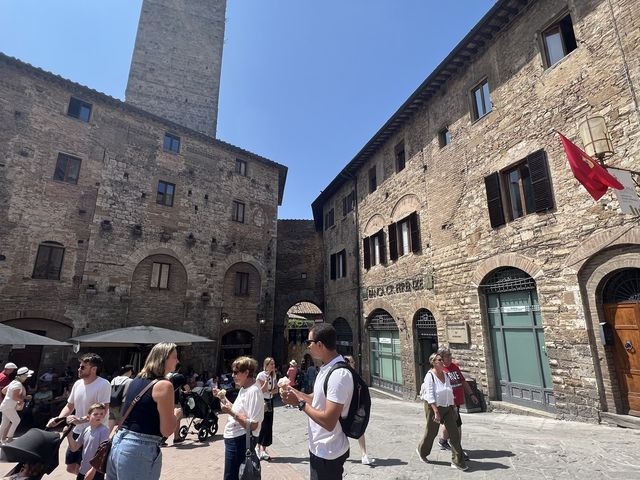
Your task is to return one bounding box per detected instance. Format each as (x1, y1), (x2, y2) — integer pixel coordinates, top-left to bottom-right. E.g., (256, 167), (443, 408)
(0, 0), (495, 218)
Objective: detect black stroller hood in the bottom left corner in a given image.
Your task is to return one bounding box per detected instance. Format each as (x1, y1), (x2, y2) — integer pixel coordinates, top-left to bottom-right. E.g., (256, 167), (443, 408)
(0, 418), (73, 480)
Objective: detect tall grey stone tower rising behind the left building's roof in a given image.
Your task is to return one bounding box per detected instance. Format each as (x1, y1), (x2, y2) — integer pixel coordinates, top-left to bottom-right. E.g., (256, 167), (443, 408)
(126, 0), (227, 137)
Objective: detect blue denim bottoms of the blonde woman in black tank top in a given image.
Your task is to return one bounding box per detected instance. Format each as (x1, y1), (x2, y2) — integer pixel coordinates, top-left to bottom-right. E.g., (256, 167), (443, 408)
(107, 428), (162, 480)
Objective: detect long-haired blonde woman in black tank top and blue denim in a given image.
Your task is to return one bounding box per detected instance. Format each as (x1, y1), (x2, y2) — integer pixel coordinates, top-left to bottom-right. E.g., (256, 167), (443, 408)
(107, 343), (178, 480)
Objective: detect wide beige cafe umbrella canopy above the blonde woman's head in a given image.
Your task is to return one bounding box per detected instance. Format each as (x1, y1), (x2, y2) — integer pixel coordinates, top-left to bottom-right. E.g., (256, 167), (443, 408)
(69, 325), (215, 347)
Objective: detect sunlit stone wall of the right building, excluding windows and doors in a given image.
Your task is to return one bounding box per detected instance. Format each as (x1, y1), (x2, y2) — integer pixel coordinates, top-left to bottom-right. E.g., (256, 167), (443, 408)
(318, 0), (640, 421)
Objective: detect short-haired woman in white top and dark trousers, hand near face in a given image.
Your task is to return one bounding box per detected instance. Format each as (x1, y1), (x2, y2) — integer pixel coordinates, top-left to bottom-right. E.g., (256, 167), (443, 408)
(214, 357), (264, 480)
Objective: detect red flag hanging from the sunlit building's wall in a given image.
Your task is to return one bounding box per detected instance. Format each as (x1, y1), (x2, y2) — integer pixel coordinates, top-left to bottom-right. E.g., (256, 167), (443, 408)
(558, 132), (624, 202)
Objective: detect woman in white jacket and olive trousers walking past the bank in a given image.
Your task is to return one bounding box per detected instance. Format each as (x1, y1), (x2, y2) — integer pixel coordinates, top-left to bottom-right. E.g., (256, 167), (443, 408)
(416, 353), (469, 470)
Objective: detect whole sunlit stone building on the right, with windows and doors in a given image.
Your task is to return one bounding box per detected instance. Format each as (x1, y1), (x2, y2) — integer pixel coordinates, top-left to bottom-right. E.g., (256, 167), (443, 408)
(313, 0), (640, 421)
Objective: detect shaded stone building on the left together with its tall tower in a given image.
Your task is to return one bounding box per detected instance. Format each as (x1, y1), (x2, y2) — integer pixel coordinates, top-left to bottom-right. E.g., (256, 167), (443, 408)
(0, 0), (287, 371)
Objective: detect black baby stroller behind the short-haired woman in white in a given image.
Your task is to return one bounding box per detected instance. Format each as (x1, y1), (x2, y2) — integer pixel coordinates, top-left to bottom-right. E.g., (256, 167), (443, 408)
(180, 387), (220, 442)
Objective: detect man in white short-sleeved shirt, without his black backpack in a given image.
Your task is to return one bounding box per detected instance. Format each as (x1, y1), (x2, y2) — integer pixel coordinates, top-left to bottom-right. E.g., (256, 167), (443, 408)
(282, 323), (353, 480)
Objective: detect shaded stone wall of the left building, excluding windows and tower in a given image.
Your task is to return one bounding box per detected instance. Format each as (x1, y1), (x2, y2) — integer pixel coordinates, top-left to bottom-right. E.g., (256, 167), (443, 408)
(0, 57), (286, 376)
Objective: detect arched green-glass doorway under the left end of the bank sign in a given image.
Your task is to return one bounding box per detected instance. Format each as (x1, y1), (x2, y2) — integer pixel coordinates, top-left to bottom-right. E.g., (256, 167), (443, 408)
(367, 309), (404, 394)
